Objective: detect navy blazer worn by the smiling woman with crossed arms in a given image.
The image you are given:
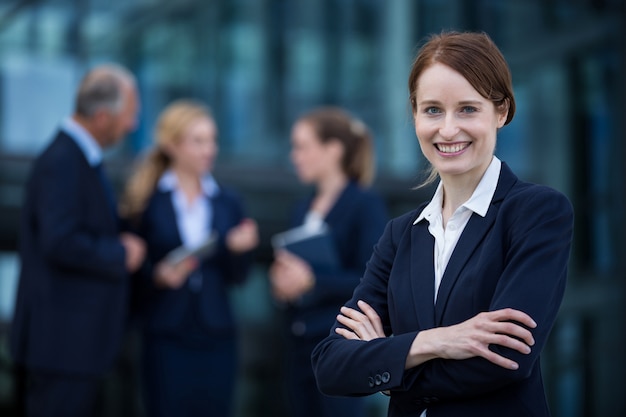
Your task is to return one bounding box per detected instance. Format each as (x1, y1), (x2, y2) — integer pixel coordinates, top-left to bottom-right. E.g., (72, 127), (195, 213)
(312, 164), (573, 417)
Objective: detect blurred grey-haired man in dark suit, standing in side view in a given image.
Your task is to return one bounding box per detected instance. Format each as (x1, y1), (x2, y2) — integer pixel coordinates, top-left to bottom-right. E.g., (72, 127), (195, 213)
(10, 65), (145, 417)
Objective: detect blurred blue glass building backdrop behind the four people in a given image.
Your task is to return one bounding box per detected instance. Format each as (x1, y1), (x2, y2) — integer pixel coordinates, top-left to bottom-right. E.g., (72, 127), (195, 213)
(0, 0), (626, 417)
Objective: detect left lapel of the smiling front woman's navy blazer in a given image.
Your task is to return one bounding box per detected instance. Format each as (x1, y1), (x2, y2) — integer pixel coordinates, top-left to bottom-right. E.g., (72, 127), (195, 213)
(410, 220), (435, 329)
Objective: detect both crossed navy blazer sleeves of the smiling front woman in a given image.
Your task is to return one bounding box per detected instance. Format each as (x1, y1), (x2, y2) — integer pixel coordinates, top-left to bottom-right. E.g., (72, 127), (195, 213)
(312, 187), (573, 400)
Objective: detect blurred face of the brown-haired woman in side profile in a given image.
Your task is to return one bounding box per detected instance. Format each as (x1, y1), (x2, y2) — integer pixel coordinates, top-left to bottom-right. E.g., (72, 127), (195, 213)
(291, 121), (340, 184)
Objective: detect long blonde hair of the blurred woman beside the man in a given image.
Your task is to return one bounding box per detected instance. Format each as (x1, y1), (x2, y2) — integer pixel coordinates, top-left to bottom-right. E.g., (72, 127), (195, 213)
(120, 99), (213, 221)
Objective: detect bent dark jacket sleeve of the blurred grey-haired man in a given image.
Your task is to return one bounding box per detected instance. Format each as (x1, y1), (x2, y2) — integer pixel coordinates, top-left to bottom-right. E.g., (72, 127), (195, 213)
(32, 143), (126, 280)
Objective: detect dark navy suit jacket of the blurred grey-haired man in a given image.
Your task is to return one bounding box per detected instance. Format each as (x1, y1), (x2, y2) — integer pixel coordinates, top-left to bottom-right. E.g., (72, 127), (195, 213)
(11, 131), (128, 374)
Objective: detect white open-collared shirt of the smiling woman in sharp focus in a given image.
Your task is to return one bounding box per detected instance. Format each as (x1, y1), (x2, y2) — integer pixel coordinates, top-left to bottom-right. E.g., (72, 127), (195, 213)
(413, 156), (502, 301)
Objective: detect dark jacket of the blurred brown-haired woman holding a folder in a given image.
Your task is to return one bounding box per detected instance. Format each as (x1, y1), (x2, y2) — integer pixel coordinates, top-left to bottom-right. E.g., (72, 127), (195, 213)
(289, 182), (389, 340)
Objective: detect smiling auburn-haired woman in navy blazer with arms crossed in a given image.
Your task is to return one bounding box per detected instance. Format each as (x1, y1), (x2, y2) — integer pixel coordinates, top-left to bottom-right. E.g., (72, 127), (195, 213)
(312, 32), (573, 417)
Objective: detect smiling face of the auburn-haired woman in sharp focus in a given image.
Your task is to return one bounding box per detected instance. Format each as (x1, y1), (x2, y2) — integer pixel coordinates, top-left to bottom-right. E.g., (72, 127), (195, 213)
(414, 63), (506, 181)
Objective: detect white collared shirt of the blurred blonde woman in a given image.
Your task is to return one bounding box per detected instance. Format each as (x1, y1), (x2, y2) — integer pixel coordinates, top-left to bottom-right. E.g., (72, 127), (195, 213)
(157, 170), (219, 249)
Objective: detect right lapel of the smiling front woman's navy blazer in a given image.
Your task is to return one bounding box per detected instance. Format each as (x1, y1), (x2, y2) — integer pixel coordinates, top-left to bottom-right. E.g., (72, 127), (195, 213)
(435, 162), (517, 325)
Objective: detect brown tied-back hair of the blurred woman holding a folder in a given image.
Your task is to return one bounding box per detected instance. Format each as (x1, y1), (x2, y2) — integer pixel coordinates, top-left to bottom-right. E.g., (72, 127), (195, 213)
(298, 107), (375, 186)
